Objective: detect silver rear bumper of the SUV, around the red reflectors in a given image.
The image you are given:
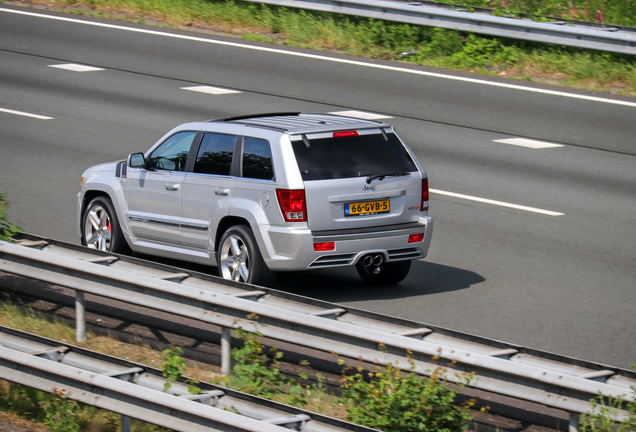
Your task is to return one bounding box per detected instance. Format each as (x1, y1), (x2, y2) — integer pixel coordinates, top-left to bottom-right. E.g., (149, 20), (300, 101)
(261, 216), (433, 271)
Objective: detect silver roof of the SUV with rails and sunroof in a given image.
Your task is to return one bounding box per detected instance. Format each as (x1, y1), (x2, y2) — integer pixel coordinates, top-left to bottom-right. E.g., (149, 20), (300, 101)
(207, 113), (391, 133)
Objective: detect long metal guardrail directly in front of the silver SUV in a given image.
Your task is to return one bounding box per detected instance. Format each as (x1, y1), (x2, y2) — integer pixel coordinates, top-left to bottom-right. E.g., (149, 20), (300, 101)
(0, 237), (636, 431)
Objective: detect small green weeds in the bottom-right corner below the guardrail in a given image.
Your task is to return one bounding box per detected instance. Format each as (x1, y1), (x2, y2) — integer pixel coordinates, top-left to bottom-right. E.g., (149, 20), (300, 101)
(580, 387), (636, 432)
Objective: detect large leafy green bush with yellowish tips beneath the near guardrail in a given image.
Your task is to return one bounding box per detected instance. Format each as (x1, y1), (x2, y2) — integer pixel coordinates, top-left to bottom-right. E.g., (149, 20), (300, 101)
(340, 353), (476, 432)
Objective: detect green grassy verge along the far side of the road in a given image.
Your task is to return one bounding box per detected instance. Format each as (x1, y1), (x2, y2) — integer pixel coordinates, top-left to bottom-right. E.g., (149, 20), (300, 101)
(9, 0), (636, 96)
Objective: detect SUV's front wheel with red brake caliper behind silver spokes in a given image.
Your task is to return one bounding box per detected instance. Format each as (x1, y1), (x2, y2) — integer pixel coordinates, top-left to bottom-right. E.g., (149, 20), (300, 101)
(82, 197), (129, 253)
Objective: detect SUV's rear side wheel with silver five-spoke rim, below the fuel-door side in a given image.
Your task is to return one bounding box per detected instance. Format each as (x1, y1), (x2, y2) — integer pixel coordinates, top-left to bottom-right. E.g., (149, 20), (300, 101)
(216, 225), (274, 286)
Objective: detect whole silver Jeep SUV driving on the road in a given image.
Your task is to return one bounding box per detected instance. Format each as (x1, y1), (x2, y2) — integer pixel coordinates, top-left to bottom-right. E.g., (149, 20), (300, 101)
(77, 113), (433, 285)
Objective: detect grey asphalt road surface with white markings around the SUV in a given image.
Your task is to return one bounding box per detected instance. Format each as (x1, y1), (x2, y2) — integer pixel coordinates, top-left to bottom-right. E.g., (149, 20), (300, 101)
(0, 5), (636, 367)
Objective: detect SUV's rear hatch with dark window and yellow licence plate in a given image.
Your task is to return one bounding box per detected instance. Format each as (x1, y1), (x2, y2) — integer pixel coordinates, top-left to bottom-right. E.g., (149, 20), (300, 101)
(292, 128), (425, 231)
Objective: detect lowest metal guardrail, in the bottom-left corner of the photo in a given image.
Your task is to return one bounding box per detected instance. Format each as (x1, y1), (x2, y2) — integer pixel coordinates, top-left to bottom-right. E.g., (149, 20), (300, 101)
(0, 326), (375, 432)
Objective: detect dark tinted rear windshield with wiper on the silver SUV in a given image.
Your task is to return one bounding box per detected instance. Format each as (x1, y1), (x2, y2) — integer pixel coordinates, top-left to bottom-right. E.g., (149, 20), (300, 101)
(292, 133), (417, 180)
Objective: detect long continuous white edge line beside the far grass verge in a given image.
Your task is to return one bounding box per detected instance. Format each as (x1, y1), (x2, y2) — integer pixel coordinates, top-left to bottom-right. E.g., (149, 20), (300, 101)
(0, 8), (636, 108)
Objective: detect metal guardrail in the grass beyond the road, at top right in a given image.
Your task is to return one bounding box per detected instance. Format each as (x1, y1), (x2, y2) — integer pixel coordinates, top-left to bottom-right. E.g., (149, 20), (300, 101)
(238, 0), (636, 55)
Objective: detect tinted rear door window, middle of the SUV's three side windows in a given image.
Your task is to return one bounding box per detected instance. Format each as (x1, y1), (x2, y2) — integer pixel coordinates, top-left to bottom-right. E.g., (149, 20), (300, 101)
(194, 133), (235, 175)
